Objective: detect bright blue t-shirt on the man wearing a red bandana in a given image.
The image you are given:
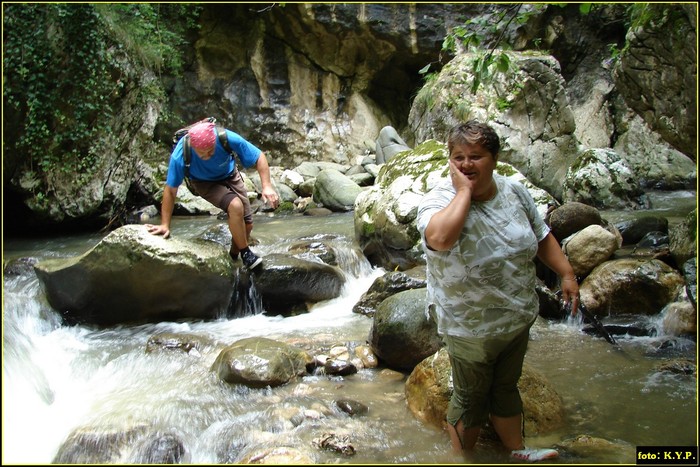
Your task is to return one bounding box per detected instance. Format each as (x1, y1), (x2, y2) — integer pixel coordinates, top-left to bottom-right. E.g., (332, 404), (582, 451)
(165, 130), (262, 188)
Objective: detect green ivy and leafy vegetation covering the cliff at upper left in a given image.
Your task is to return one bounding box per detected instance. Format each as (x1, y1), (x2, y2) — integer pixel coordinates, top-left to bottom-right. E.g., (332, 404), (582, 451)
(3, 3), (201, 197)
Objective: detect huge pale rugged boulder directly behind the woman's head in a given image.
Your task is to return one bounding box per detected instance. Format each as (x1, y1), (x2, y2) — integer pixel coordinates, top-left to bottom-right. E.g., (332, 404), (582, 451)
(408, 52), (580, 200)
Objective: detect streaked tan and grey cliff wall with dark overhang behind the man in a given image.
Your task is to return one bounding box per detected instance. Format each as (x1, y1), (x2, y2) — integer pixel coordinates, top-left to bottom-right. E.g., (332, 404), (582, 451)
(171, 3), (485, 167)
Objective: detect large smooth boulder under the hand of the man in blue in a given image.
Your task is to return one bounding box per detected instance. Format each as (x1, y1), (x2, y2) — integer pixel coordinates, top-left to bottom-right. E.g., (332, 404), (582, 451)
(34, 225), (234, 325)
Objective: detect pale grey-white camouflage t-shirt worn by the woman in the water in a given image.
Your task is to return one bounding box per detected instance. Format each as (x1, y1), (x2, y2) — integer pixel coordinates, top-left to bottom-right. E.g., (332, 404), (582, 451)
(417, 174), (549, 337)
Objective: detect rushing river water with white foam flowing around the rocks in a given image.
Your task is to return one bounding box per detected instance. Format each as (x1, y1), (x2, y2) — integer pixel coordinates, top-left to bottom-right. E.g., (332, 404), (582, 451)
(2, 192), (698, 465)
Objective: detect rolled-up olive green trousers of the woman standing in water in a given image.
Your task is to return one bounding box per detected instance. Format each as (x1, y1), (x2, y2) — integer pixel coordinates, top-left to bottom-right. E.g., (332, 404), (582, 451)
(444, 326), (530, 428)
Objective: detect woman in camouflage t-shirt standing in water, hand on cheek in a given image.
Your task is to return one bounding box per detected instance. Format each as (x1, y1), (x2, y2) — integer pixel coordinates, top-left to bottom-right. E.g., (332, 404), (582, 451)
(417, 120), (578, 461)
